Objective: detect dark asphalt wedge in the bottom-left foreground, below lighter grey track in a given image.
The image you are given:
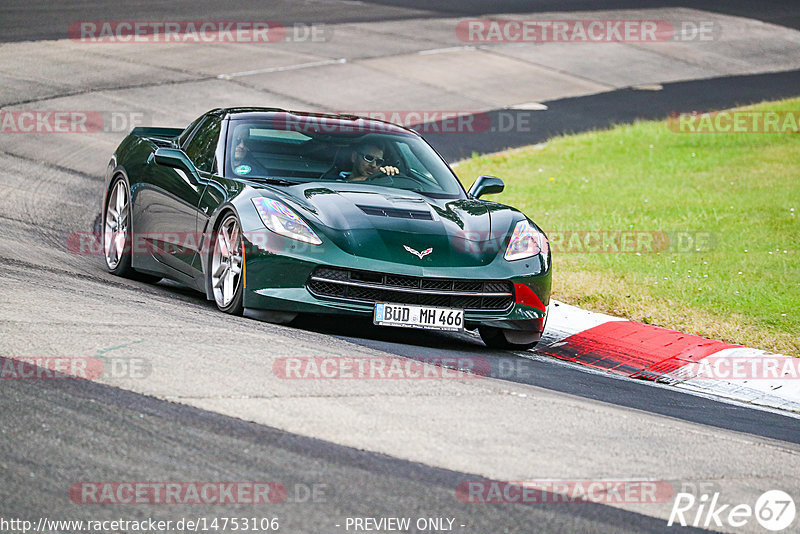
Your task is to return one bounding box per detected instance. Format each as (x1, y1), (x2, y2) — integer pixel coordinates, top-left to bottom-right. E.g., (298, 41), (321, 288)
(0, 379), (712, 534)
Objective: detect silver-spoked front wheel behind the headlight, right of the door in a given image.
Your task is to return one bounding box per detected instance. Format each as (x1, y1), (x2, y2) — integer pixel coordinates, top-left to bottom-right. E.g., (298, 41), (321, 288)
(210, 213), (244, 315)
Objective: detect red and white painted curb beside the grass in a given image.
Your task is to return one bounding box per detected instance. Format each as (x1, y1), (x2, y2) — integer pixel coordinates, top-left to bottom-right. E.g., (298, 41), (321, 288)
(536, 301), (800, 413)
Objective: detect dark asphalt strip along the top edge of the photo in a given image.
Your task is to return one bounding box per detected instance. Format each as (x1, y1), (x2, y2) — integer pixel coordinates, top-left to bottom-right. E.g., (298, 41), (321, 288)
(0, 0), (800, 42)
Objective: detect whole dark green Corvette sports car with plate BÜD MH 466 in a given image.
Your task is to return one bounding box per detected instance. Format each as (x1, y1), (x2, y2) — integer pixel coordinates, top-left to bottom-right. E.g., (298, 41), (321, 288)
(102, 108), (551, 348)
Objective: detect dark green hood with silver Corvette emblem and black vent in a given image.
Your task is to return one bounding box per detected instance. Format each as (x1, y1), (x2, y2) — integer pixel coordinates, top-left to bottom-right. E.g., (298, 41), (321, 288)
(272, 183), (524, 267)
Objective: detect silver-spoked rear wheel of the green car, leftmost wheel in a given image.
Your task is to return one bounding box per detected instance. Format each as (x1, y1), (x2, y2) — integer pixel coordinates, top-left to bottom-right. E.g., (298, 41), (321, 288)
(103, 178), (161, 282)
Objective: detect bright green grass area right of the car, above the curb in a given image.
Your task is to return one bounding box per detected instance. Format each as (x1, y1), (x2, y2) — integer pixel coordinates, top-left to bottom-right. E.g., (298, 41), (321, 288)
(456, 98), (800, 354)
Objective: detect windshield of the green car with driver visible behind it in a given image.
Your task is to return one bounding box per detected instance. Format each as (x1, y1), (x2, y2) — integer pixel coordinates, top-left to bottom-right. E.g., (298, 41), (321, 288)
(225, 114), (465, 198)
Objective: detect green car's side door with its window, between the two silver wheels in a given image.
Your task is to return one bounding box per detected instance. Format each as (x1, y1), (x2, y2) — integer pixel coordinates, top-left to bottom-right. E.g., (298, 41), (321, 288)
(149, 115), (222, 285)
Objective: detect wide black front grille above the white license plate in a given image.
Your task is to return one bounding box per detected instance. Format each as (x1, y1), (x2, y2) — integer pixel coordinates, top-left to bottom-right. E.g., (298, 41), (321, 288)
(306, 267), (514, 312)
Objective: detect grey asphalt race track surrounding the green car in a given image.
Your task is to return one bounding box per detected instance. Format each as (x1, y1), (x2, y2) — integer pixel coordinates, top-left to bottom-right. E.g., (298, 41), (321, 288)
(0, 0), (800, 534)
